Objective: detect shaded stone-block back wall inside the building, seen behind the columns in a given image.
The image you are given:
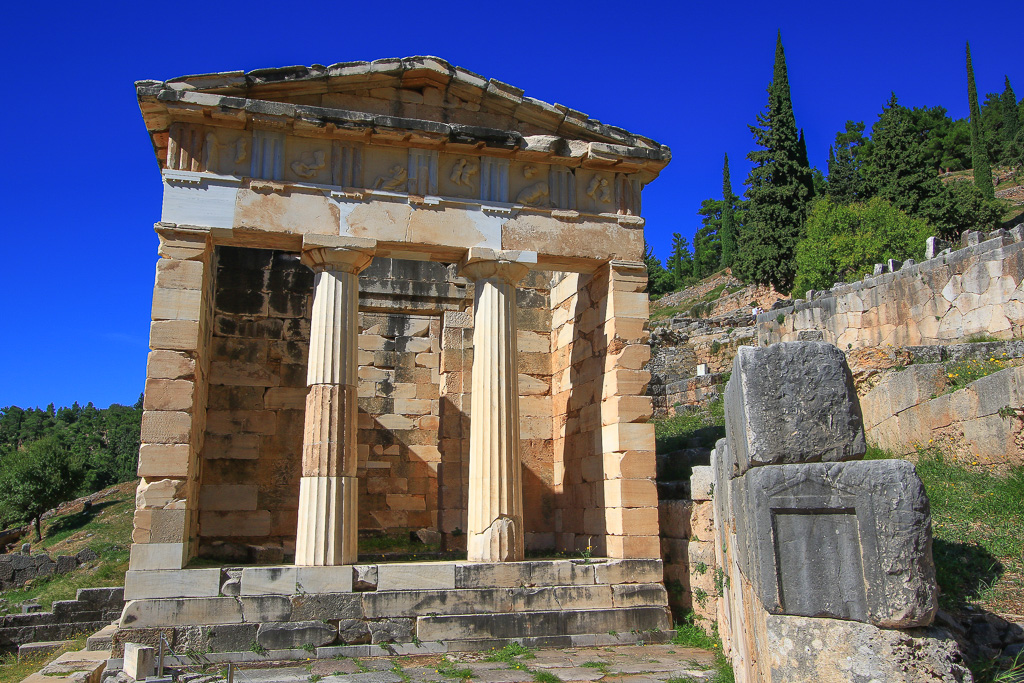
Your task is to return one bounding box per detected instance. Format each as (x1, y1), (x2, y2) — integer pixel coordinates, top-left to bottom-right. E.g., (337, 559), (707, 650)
(192, 247), (555, 562)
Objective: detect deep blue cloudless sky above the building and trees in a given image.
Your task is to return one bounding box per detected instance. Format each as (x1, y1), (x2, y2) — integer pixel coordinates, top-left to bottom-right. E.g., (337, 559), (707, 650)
(0, 0), (1024, 407)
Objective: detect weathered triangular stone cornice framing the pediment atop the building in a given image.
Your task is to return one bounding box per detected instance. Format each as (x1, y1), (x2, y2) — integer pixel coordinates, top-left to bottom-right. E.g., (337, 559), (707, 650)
(136, 57), (671, 181)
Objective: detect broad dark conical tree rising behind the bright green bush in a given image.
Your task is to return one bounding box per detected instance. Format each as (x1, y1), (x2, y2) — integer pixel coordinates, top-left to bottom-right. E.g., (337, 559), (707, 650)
(864, 93), (941, 216)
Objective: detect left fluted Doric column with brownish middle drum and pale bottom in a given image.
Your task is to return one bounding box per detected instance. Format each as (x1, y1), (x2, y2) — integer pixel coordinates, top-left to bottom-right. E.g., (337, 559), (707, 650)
(295, 236), (377, 566)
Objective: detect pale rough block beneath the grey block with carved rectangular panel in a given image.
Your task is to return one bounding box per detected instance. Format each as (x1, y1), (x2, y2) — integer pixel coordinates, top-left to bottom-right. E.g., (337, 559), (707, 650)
(763, 614), (972, 683)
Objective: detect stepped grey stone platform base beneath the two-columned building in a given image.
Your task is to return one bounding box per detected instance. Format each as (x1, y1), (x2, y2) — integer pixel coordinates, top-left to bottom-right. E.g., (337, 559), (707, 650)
(114, 559), (671, 660)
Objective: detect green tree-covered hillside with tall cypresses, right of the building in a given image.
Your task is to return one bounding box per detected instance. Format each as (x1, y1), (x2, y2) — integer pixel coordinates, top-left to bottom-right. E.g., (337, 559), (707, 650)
(645, 35), (1024, 296)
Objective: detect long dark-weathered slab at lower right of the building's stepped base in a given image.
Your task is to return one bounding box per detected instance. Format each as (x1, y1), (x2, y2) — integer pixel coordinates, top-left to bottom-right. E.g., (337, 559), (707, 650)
(416, 607), (672, 641)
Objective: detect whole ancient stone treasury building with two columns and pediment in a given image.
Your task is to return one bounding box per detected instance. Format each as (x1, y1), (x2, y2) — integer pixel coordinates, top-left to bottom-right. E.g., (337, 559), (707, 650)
(125, 57), (670, 651)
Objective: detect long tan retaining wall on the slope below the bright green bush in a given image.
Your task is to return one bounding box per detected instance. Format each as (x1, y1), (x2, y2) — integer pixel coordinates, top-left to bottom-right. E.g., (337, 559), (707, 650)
(758, 226), (1024, 349)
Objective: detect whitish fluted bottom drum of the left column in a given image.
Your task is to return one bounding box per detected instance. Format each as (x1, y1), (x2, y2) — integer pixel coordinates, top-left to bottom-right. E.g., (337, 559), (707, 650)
(295, 476), (358, 566)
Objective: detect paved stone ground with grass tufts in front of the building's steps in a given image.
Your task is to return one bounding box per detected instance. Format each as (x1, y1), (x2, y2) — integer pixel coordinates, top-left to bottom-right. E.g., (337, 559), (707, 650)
(211, 644), (715, 683)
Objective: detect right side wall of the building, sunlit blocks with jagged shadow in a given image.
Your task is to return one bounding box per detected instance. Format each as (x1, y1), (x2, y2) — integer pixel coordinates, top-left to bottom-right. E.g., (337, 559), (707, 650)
(551, 261), (660, 557)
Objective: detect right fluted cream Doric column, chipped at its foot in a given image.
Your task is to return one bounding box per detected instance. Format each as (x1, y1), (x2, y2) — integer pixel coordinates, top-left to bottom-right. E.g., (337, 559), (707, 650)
(461, 248), (537, 562)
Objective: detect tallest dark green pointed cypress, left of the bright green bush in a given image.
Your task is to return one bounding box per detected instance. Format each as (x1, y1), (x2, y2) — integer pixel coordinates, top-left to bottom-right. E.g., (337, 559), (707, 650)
(740, 32), (812, 292)
